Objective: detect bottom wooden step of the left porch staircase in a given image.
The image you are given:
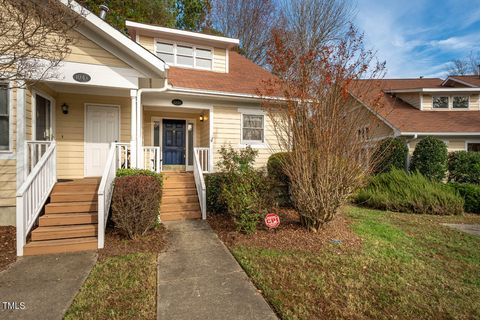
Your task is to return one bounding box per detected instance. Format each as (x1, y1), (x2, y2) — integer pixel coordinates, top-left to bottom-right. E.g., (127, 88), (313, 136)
(23, 237), (98, 256)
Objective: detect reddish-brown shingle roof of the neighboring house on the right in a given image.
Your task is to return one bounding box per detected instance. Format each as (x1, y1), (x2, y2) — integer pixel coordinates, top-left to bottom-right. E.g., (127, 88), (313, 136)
(354, 78), (480, 135)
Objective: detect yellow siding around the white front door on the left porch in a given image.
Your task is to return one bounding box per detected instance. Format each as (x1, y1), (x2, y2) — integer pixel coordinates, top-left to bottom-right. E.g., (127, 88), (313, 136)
(55, 93), (131, 179)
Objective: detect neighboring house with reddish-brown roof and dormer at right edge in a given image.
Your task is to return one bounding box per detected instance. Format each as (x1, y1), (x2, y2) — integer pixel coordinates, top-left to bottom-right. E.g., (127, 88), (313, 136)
(354, 76), (480, 152)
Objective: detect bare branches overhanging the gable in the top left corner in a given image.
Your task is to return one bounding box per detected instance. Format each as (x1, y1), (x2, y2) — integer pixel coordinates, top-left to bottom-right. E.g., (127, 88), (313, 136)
(0, 0), (83, 83)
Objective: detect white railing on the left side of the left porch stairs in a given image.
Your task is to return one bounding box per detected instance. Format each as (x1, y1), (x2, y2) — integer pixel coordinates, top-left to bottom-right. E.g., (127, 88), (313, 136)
(16, 141), (57, 256)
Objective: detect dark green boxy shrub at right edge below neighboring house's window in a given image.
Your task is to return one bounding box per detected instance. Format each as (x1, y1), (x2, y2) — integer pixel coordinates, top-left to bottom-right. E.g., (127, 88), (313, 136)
(448, 151), (480, 184)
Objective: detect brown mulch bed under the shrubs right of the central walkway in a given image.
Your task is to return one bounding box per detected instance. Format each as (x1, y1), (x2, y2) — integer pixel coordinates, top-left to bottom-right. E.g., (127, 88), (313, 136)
(208, 210), (361, 252)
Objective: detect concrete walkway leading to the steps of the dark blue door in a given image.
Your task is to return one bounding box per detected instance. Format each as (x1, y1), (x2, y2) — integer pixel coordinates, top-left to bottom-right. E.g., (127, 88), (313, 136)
(157, 220), (277, 320)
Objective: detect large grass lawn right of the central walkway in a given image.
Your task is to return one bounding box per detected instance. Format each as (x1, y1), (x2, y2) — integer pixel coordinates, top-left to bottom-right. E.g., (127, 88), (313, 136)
(212, 207), (480, 319)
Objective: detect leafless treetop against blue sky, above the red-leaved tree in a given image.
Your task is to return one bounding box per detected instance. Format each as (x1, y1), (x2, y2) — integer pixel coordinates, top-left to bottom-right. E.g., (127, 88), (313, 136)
(282, 0), (355, 54)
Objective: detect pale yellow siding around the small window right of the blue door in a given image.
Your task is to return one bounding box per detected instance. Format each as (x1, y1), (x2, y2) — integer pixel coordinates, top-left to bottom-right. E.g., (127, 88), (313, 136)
(213, 106), (279, 167)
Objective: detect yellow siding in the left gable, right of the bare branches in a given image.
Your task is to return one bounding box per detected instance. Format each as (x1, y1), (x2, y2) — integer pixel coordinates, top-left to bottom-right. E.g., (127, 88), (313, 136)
(65, 32), (129, 68)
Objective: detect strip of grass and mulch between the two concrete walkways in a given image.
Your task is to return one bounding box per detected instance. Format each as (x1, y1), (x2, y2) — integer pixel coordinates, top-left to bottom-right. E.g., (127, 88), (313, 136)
(65, 227), (165, 320)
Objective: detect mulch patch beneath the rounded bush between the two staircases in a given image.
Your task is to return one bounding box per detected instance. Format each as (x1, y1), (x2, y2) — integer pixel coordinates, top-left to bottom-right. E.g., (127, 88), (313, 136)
(98, 225), (167, 260)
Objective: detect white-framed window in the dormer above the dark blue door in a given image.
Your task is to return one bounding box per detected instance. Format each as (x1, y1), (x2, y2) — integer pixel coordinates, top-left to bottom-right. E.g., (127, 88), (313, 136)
(156, 41), (213, 70)
